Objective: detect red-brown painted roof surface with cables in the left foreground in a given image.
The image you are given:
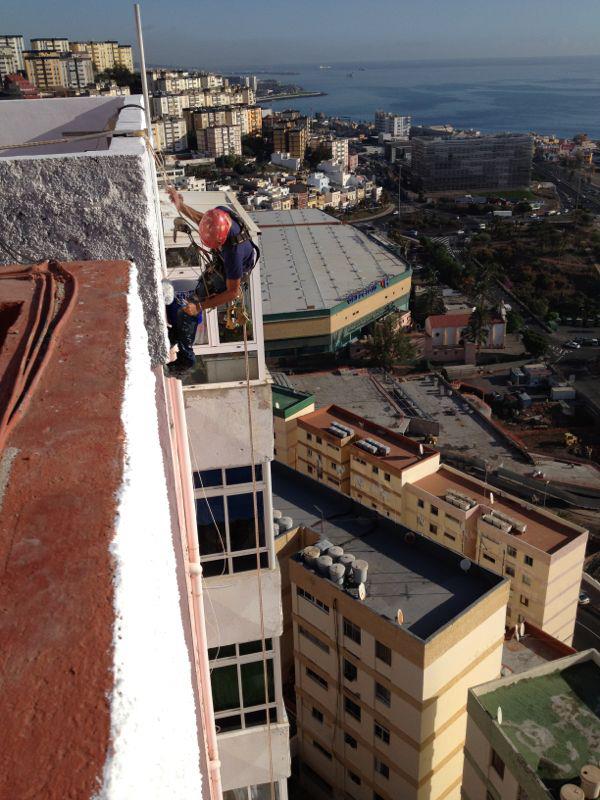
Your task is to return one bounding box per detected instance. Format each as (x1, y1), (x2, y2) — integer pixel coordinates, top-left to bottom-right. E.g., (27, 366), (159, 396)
(0, 262), (130, 800)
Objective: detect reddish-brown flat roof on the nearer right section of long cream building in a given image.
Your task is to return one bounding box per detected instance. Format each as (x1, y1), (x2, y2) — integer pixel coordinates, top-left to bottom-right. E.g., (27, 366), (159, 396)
(413, 465), (583, 553)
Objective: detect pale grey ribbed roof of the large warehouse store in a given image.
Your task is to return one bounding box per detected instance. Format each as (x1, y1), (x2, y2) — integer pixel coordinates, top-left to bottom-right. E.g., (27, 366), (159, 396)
(250, 208), (408, 315)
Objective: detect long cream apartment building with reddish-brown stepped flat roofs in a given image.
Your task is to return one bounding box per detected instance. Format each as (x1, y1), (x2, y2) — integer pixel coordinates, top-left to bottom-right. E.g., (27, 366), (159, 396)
(297, 406), (587, 644)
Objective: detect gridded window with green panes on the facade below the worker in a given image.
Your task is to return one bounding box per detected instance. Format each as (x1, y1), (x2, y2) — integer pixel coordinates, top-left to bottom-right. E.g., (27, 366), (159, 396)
(210, 642), (277, 732)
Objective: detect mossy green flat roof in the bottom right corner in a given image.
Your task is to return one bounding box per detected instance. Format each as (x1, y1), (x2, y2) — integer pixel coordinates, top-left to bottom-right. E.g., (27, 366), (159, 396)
(476, 651), (600, 797)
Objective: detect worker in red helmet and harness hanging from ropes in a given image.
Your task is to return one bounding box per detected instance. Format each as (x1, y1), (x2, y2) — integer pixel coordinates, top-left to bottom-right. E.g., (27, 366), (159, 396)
(167, 187), (259, 379)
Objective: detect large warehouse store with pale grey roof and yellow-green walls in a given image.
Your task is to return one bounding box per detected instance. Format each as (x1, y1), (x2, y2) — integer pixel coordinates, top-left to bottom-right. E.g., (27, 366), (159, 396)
(251, 209), (411, 358)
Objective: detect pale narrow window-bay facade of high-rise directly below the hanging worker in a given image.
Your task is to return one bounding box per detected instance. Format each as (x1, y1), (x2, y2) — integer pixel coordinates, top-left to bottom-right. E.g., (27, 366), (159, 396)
(163, 191), (290, 800)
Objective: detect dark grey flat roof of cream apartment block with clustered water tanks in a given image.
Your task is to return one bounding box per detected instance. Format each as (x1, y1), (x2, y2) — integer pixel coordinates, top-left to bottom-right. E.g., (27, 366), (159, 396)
(273, 462), (505, 641)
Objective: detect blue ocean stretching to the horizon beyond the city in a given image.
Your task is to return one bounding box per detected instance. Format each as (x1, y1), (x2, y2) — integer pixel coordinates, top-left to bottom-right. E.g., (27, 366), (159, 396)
(248, 56), (600, 138)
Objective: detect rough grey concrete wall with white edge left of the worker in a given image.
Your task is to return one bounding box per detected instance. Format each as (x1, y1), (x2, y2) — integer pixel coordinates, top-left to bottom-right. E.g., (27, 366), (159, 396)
(0, 148), (168, 368)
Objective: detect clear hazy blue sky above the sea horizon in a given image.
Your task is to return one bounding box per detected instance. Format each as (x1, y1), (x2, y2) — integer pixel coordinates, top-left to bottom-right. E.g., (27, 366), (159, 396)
(0, 0), (600, 69)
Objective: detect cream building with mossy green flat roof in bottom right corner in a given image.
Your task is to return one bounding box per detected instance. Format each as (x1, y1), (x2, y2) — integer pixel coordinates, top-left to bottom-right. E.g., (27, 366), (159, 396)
(462, 650), (600, 800)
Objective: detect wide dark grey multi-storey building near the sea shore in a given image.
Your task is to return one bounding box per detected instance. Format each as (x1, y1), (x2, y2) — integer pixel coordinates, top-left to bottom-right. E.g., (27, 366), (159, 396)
(411, 133), (533, 192)
